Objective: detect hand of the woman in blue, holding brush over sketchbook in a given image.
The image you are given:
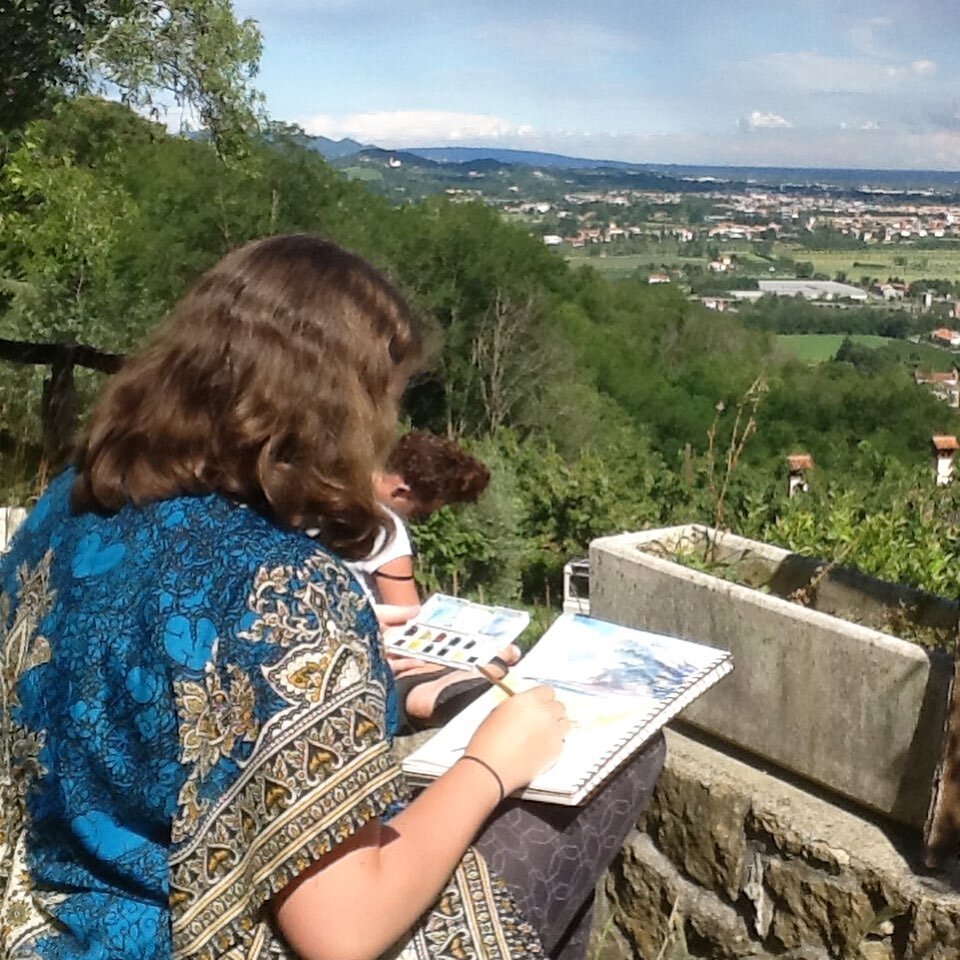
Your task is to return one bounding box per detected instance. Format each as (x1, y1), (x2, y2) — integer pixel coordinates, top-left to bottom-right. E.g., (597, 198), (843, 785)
(466, 686), (570, 794)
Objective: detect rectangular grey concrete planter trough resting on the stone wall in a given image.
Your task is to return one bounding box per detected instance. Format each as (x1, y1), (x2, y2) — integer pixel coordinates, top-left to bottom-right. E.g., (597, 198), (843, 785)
(590, 525), (957, 827)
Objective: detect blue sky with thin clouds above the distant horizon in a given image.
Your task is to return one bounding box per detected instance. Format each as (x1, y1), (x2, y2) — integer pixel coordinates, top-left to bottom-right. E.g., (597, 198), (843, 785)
(235, 0), (960, 170)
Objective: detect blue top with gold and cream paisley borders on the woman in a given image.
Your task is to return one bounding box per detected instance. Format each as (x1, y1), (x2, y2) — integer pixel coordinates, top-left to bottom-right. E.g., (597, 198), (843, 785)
(0, 471), (542, 960)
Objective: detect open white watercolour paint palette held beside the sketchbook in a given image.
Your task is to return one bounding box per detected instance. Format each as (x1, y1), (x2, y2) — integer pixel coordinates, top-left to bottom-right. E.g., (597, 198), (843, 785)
(383, 593), (530, 670)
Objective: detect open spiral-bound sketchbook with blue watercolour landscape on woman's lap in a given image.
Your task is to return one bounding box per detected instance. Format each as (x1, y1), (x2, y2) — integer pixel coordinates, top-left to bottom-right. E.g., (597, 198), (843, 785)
(403, 614), (733, 806)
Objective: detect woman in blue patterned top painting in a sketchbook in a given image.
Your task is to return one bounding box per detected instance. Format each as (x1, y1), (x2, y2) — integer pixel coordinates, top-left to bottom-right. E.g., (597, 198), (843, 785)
(0, 235), (662, 960)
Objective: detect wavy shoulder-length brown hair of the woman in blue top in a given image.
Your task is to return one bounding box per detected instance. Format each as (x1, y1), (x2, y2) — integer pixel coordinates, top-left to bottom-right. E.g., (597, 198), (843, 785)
(73, 234), (421, 557)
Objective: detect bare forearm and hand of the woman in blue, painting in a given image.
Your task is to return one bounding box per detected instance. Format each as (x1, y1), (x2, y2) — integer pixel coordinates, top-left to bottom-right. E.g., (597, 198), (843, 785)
(274, 687), (569, 960)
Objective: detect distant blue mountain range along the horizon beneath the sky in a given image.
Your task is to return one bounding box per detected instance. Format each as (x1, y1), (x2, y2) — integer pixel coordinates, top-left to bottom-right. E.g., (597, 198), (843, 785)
(303, 137), (960, 194)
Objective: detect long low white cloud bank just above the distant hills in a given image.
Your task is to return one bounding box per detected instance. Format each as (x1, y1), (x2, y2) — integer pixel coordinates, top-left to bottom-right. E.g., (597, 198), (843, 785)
(297, 110), (533, 147)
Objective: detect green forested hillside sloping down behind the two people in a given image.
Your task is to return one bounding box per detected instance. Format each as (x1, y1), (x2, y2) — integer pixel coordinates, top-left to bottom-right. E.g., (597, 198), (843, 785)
(0, 99), (957, 599)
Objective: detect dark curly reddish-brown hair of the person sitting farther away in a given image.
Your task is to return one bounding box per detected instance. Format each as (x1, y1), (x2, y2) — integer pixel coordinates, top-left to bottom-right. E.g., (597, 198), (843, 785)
(387, 430), (490, 504)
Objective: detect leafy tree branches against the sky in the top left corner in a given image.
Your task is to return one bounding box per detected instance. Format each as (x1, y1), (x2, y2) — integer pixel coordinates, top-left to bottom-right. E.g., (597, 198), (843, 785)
(0, 0), (262, 156)
